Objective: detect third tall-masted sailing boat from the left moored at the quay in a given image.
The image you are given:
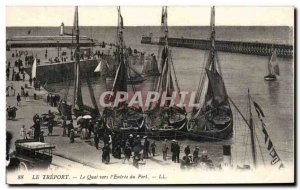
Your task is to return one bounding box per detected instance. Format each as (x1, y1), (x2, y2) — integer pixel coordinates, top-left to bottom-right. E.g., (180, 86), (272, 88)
(145, 7), (187, 138)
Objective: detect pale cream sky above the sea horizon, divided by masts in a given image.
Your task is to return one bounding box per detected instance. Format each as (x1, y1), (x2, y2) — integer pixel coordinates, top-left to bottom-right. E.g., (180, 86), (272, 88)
(6, 6), (294, 26)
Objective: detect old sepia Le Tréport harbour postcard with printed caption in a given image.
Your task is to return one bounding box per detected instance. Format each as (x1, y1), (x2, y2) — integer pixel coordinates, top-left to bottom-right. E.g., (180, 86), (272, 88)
(6, 5), (295, 185)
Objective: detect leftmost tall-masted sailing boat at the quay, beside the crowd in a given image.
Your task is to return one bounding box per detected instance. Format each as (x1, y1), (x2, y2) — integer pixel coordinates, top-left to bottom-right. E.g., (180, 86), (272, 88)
(58, 6), (99, 118)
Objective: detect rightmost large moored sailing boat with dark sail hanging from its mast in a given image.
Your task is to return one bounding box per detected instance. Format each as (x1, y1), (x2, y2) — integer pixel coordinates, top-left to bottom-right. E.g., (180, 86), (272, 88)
(187, 7), (233, 141)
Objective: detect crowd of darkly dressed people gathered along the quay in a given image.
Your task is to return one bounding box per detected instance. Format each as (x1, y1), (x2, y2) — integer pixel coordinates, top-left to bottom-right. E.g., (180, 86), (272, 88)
(7, 49), (214, 171)
